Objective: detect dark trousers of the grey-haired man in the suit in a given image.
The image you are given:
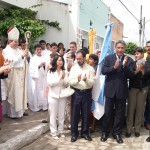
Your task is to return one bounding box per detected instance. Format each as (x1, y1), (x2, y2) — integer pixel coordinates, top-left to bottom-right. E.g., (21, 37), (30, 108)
(102, 97), (126, 135)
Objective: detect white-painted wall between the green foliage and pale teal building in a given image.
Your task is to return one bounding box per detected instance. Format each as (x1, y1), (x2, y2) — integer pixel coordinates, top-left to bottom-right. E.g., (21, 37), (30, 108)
(37, 0), (79, 49)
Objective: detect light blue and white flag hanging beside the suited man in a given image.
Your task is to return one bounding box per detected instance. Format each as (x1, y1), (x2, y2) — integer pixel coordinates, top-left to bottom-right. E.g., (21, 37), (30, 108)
(92, 23), (114, 120)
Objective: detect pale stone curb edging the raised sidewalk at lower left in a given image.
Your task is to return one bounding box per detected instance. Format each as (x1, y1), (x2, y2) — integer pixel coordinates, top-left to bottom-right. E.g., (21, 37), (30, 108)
(0, 123), (49, 150)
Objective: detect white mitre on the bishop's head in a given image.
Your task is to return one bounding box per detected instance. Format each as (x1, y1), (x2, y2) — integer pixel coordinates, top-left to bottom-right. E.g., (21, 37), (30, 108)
(7, 27), (20, 40)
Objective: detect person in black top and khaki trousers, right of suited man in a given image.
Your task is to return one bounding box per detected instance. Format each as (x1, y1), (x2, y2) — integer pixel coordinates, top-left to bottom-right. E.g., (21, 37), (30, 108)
(126, 47), (148, 138)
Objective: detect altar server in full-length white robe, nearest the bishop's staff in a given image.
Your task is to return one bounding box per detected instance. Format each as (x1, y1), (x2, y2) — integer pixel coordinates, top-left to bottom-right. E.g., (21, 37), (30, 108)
(29, 44), (48, 112)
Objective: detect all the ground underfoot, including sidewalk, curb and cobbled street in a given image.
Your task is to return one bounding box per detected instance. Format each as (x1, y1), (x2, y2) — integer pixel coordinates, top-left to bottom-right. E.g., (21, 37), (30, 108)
(0, 110), (150, 150)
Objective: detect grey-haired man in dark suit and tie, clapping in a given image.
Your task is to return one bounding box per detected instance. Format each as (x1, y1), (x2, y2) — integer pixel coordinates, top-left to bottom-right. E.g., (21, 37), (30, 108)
(101, 40), (135, 143)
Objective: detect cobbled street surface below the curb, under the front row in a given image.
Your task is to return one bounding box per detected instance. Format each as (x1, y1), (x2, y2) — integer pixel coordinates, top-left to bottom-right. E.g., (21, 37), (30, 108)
(21, 126), (150, 150)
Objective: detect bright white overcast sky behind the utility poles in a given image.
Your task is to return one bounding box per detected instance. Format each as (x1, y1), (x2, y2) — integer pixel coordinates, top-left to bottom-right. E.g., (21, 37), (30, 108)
(102, 0), (150, 44)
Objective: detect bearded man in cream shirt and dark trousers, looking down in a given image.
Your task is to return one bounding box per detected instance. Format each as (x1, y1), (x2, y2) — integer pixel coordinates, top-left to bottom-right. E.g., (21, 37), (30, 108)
(69, 50), (95, 142)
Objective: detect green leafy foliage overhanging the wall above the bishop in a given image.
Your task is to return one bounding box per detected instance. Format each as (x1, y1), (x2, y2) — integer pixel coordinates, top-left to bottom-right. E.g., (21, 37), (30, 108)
(0, 8), (61, 43)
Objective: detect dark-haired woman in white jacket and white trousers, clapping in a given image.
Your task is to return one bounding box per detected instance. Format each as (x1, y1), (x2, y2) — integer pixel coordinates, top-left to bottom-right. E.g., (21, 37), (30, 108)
(47, 55), (68, 139)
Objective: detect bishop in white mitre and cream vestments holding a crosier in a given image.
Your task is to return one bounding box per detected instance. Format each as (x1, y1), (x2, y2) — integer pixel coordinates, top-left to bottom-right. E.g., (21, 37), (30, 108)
(2, 27), (28, 118)
